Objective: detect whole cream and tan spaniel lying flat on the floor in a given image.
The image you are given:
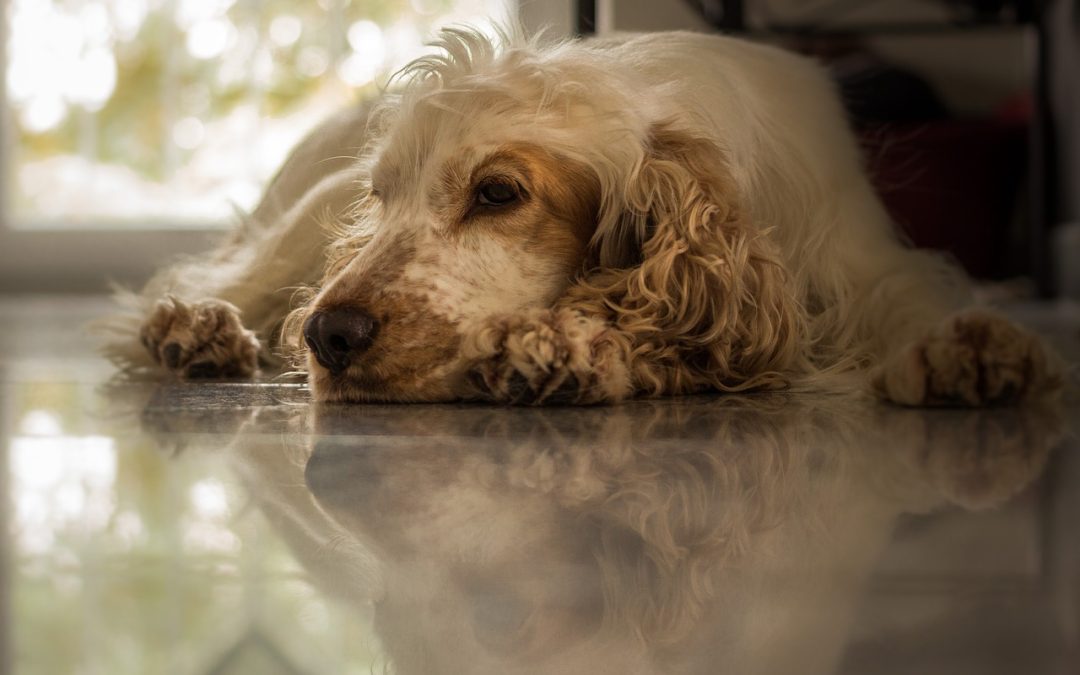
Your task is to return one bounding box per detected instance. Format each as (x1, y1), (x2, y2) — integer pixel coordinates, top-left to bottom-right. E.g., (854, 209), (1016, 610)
(108, 28), (1061, 406)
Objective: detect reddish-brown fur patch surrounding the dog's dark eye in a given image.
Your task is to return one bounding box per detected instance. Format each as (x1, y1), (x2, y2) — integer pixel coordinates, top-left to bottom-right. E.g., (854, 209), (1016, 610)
(430, 143), (600, 272)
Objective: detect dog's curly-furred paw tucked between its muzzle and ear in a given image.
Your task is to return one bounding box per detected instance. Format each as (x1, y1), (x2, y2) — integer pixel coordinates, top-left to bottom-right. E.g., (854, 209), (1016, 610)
(468, 309), (630, 405)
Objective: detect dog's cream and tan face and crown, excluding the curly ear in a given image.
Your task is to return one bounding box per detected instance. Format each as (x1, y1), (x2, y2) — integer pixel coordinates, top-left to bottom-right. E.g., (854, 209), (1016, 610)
(294, 30), (632, 401)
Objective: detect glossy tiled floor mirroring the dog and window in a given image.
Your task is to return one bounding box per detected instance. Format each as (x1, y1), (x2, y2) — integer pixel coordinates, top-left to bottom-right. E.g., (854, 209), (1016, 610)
(0, 298), (1080, 675)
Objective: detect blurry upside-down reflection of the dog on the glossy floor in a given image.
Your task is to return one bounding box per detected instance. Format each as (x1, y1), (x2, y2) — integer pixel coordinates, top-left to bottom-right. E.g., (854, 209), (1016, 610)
(223, 396), (1059, 675)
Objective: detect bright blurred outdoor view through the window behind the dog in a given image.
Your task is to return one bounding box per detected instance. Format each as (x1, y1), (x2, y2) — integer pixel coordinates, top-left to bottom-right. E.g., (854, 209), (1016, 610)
(3, 0), (507, 228)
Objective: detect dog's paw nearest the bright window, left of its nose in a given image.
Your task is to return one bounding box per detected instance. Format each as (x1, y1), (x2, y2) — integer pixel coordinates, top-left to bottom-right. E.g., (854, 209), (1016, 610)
(139, 296), (259, 379)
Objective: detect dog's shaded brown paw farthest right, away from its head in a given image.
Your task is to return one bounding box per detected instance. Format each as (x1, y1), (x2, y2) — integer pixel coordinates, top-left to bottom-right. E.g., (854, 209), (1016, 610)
(870, 311), (1059, 406)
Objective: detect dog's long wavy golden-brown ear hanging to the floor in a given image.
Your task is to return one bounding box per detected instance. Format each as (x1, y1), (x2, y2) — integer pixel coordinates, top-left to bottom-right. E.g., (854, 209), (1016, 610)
(565, 124), (809, 395)
